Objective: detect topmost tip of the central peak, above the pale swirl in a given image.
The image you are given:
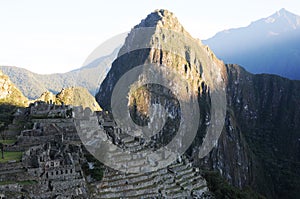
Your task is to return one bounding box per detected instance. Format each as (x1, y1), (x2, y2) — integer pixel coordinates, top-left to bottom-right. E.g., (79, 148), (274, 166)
(134, 9), (185, 32)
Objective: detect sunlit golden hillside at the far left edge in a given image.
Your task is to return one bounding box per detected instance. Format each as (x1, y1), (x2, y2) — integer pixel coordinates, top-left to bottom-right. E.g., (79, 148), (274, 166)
(0, 71), (28, 106)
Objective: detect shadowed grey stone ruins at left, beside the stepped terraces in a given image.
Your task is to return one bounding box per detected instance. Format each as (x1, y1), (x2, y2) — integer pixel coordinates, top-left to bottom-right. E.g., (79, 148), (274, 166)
(0, 102), (89, 198)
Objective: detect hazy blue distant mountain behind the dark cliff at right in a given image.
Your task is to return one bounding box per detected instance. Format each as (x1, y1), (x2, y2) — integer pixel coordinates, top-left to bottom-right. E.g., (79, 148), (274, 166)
(203, 9), (300, 80)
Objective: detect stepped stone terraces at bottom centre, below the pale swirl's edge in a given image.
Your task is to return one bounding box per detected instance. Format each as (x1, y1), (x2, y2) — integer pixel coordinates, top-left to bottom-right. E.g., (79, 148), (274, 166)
(94, 159), (210, 198)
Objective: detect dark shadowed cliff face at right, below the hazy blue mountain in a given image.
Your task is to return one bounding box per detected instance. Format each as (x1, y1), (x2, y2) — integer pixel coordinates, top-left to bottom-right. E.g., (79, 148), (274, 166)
(227, 65), (300, 198)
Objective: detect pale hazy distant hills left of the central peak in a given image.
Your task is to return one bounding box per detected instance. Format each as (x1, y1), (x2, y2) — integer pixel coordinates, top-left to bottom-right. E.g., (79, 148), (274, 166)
(0, 46), (118, 99)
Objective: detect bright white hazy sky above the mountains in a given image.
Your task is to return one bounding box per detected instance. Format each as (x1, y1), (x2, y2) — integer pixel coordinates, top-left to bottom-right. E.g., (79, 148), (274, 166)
(0, 0), (300, 73)
